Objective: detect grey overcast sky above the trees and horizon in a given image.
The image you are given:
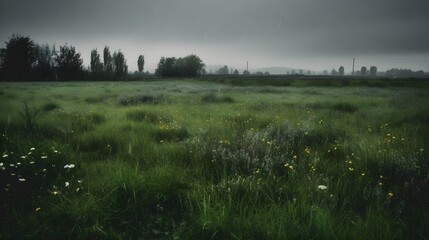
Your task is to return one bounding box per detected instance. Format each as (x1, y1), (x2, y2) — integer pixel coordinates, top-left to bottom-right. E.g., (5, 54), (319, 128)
(0, 0), (429, 72)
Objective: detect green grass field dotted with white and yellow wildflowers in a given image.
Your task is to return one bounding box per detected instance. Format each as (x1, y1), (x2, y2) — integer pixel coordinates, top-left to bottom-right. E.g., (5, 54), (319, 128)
(0, 79), (429, 239)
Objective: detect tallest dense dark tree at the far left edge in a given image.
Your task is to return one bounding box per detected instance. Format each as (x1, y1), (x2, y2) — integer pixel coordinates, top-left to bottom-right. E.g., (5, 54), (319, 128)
(2, 34), (35, 81)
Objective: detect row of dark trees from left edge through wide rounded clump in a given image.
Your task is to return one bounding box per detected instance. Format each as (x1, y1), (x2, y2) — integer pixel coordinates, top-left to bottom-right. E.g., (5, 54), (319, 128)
(0, 34), (205, 81)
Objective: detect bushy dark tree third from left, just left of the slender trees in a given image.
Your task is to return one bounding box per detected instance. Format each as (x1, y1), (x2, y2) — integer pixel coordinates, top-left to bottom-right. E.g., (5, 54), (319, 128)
(55, 45), (84, 81)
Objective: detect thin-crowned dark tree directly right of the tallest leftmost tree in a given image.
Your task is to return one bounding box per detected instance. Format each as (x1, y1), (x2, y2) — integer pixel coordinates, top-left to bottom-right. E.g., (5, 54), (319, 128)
(33, 43), (57, 81)
